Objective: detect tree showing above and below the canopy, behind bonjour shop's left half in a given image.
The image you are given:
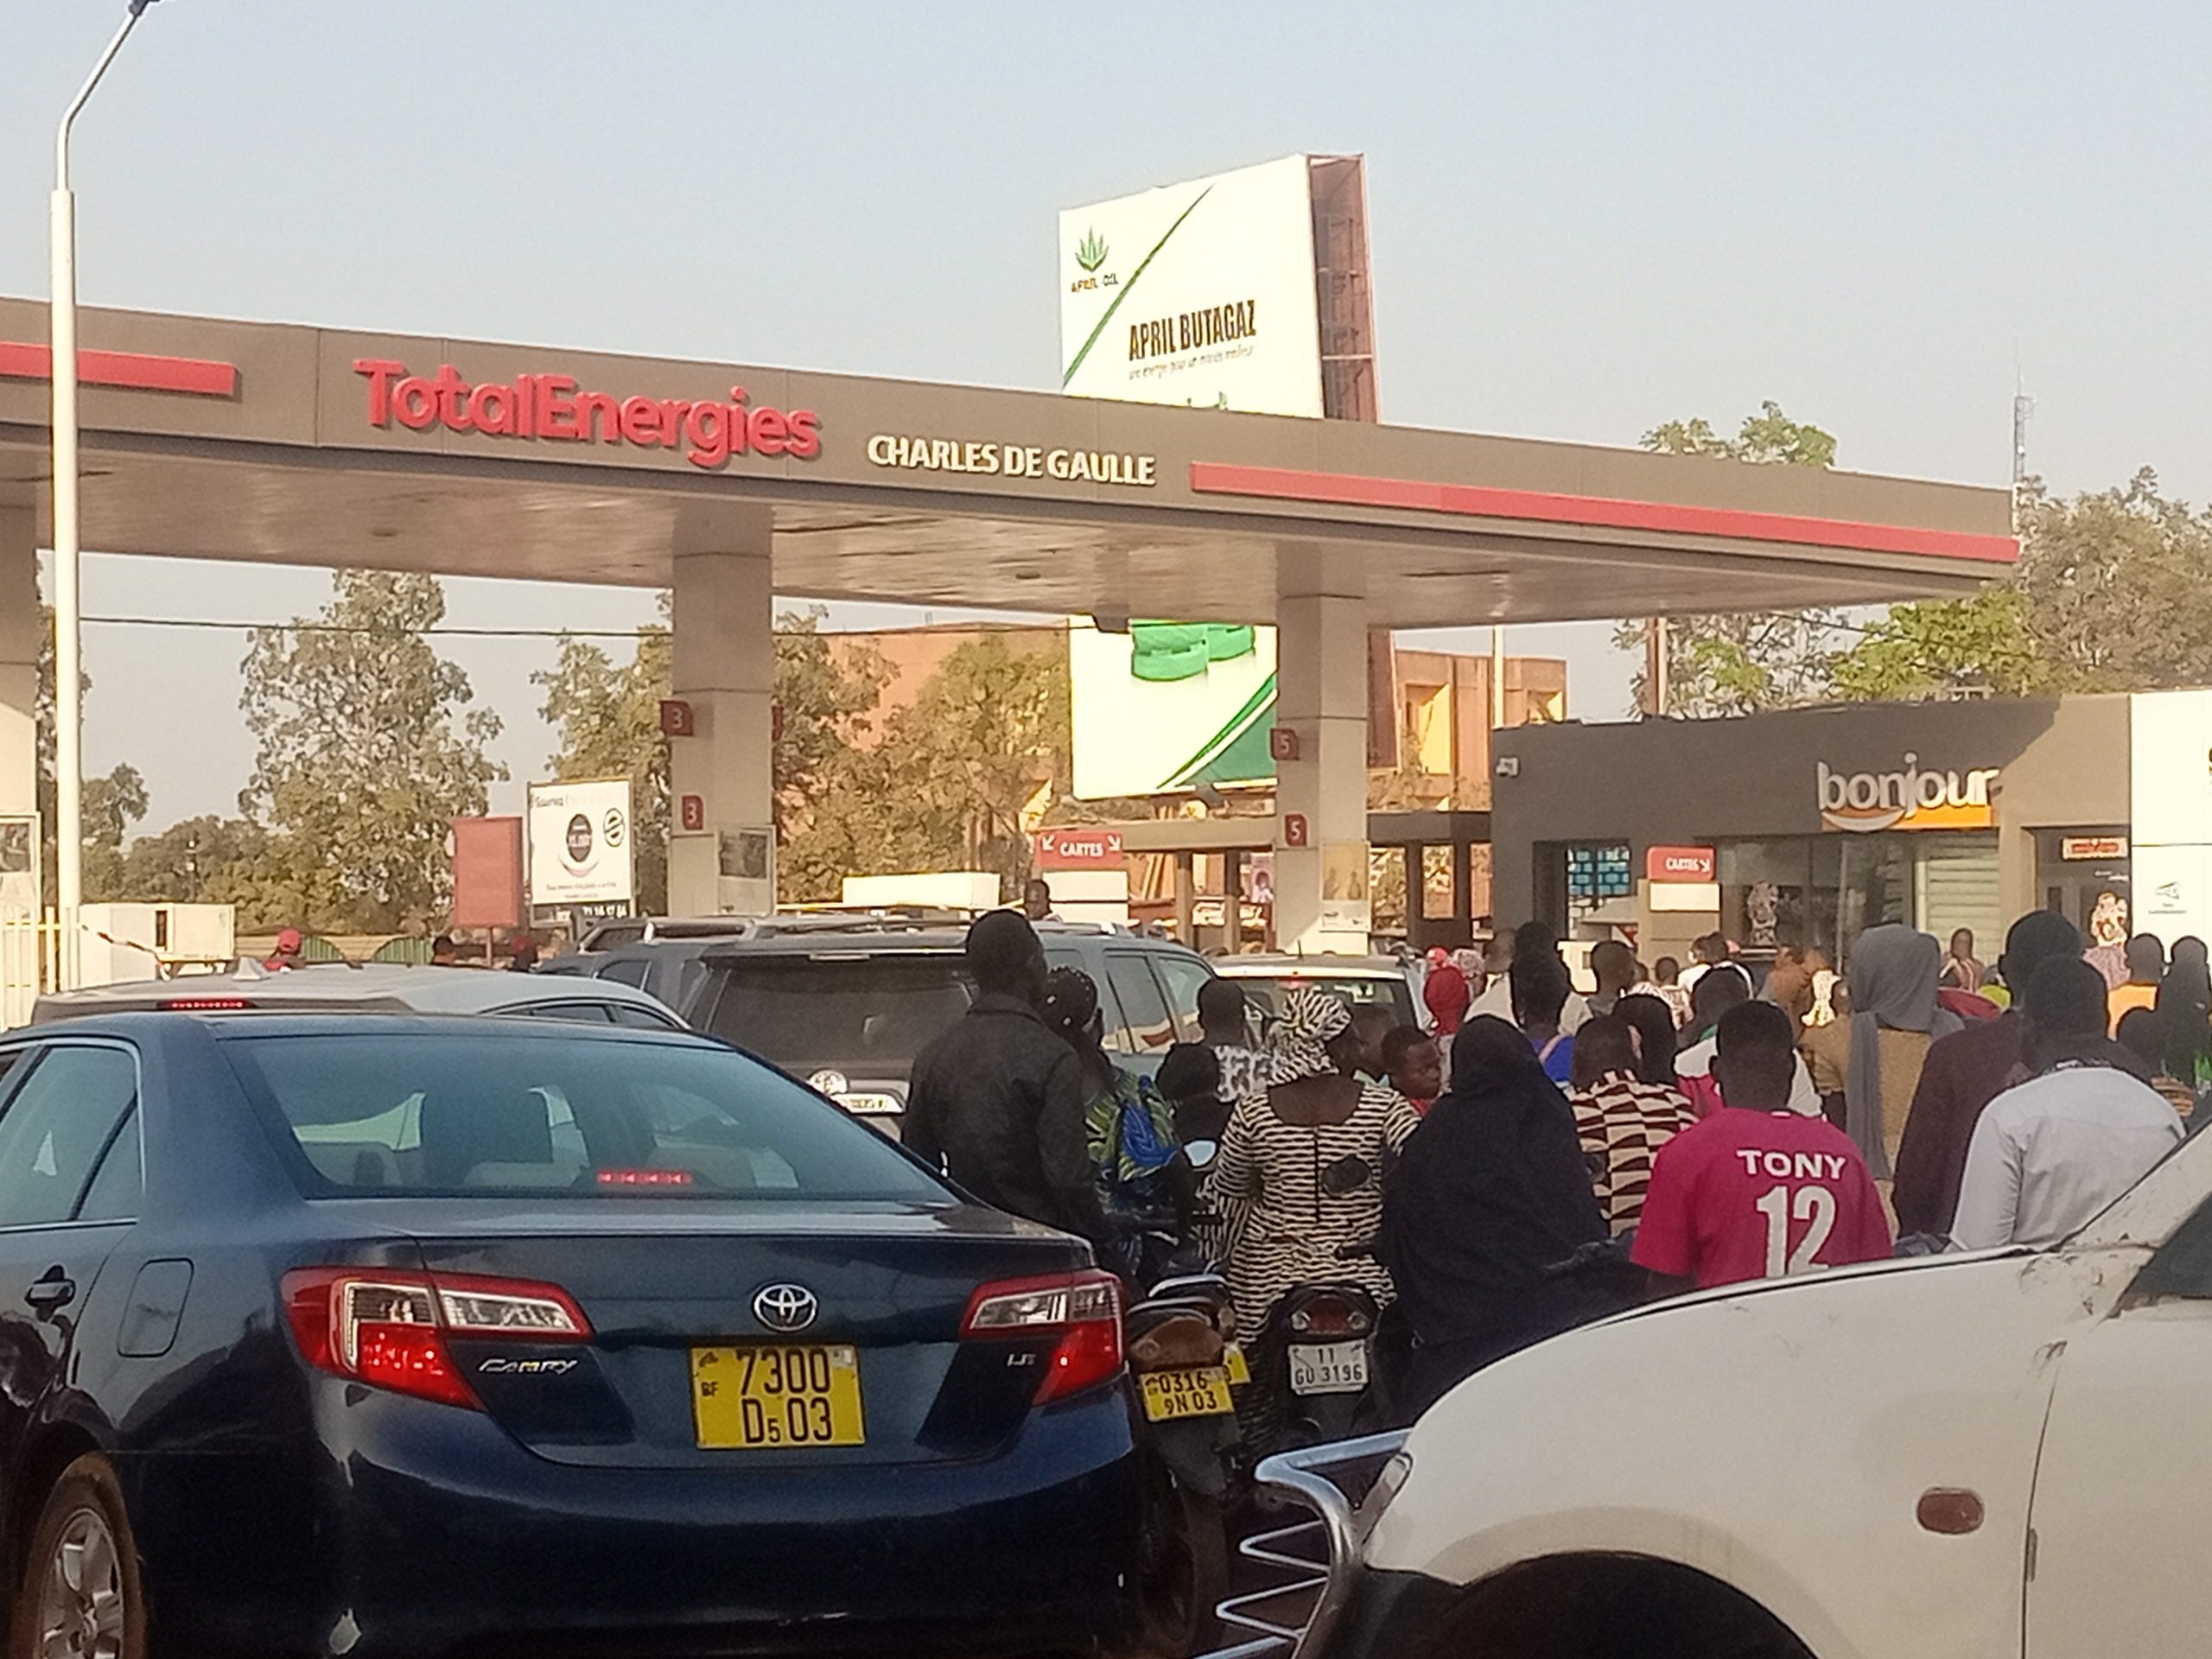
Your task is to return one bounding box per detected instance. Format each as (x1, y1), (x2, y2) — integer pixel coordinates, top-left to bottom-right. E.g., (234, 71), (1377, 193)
(1612, 400), (1840, 716)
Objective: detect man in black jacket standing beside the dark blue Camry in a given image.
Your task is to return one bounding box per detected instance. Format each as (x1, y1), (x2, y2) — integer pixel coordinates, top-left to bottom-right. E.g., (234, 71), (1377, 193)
(902, 909), (1106, 1243)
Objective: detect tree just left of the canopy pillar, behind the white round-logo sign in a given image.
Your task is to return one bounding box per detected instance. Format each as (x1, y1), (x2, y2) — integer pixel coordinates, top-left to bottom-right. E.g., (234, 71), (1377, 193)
(531, 595), (671, 916)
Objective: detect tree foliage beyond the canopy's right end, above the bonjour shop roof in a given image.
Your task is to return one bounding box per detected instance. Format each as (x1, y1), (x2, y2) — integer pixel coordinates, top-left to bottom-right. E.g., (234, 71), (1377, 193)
(1834, 467), (2212, 696)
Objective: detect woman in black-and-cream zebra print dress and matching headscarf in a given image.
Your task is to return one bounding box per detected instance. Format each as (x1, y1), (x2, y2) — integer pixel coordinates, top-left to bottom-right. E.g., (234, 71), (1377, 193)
(1212, 988), (1421, 1338)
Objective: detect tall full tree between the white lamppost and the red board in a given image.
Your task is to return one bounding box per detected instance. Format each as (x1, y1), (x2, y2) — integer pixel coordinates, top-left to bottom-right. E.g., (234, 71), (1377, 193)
(226, 570), (506, 931)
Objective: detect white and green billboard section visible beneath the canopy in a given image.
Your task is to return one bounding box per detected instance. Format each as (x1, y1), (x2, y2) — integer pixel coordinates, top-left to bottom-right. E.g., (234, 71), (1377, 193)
(1068, 620), (1274, 801)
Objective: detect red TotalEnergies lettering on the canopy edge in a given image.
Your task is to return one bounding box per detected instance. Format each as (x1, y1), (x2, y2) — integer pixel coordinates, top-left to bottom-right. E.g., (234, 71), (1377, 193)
(354, 356), (823, 467)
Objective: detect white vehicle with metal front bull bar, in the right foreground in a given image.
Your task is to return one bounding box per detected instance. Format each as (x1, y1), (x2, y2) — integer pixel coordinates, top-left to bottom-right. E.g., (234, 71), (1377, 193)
(1230, 1135), (2212, 1659)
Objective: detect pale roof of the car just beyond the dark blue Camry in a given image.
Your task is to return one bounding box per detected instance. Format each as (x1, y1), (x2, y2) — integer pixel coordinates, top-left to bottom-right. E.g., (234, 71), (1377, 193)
(31, 963), (672, 1024)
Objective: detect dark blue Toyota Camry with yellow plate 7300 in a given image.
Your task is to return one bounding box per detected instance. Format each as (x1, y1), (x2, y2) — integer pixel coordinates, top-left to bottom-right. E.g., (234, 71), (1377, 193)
(0, 1013), (1137, 1659)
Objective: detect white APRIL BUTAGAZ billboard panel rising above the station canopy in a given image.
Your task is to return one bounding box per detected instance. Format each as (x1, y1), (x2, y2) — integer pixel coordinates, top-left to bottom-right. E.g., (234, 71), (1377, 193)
(1059, 155), (1323, 418)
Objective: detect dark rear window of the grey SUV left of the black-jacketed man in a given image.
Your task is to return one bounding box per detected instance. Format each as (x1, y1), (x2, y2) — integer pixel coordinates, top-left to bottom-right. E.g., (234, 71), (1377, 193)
(708, 951), (969, 1079)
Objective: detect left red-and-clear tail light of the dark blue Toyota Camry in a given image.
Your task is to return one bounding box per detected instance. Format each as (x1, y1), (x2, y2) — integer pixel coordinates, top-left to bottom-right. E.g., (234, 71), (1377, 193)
(283, 1268), (591, 1411)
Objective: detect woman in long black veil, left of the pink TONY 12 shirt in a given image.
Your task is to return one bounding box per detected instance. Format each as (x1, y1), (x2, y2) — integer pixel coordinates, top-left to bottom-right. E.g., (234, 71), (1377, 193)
(1382, 1018), (1619, 1409)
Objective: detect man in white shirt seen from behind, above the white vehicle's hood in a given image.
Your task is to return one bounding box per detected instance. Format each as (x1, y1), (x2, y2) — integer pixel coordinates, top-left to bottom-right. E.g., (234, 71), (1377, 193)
(1951, 956), (2183, 1249)
